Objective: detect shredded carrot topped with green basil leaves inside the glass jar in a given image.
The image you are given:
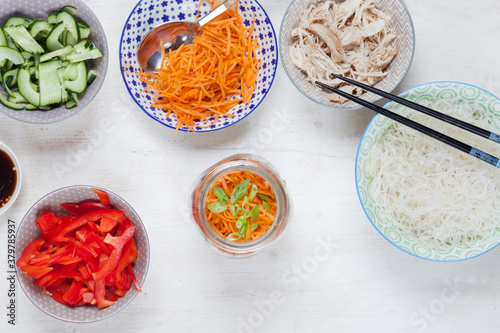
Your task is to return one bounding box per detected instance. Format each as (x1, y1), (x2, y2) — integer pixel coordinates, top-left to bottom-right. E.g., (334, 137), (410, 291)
(205, 170), (277, 243)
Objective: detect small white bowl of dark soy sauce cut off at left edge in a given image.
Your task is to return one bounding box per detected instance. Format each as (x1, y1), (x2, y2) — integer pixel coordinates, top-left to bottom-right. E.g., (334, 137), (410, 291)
(0, 142), (22, 215)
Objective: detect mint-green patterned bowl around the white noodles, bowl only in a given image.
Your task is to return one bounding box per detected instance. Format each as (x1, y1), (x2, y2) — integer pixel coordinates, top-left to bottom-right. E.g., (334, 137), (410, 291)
(355, 82), (500, 262)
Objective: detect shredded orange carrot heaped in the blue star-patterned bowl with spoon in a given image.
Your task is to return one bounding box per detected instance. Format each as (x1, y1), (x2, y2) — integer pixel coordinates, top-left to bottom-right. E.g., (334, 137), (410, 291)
(137, 0), (260, 132)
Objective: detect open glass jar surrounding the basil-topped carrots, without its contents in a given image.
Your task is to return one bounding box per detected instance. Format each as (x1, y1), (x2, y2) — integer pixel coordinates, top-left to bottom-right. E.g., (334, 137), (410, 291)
(189, 154), (292, 258)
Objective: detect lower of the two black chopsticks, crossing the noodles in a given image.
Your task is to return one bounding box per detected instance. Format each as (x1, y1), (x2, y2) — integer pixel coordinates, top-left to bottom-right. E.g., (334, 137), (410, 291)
(316, 81), (500, 168)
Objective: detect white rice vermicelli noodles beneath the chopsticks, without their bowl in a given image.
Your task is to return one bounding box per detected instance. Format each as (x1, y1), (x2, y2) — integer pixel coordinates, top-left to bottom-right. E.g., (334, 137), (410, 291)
(367, 98), (500, 251)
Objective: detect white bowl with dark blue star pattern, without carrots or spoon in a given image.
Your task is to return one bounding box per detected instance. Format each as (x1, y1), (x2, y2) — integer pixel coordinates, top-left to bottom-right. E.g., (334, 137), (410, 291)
(120, 0), (278, 132)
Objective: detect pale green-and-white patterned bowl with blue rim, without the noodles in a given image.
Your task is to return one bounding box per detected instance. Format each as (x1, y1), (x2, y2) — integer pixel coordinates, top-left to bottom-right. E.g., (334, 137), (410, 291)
(356, 82), (500, 261)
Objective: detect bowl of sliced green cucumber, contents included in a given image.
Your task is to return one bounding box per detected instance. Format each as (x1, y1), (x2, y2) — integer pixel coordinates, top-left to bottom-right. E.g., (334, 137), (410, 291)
(0, 0), (108, 124)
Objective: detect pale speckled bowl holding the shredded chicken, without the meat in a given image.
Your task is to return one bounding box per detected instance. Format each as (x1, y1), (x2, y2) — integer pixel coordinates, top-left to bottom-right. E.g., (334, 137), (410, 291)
(280, 0), (415, 110)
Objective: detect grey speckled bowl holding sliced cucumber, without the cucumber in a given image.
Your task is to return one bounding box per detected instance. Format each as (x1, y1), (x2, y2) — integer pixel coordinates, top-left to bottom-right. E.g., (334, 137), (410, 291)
(0, 0), (109, 124)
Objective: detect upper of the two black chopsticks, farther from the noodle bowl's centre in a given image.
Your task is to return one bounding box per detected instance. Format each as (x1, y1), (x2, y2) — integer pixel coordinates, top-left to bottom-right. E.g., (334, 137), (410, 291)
(330, 73), (500, 143)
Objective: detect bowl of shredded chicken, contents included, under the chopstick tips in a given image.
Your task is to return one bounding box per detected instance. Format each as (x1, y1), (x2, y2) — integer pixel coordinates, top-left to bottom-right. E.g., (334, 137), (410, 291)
(280, 0), (415, 109)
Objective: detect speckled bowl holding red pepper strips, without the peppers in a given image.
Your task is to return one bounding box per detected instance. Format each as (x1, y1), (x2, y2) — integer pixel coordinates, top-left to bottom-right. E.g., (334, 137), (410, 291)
(16, 185), (150, 323)
